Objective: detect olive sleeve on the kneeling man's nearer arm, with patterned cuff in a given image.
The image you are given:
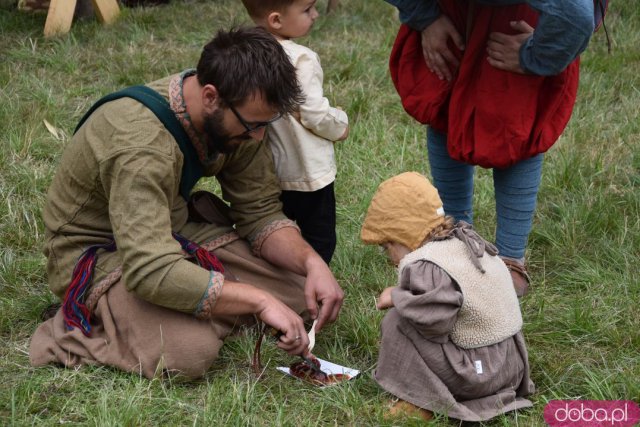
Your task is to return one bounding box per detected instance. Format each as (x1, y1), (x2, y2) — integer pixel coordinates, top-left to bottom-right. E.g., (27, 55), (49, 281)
(100, 142), (224, 316)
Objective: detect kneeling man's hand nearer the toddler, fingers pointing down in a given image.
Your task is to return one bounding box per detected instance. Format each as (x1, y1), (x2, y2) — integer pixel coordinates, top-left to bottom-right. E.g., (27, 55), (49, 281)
(304, 257), (344, 331)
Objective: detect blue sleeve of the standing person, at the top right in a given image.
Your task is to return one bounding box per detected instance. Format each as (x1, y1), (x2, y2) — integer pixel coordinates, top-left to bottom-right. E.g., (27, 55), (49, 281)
(520, 0), (593, 76)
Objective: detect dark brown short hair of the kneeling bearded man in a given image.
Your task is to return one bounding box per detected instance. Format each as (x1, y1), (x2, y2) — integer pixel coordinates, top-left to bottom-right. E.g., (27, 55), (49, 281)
(197, 27), (304, 114)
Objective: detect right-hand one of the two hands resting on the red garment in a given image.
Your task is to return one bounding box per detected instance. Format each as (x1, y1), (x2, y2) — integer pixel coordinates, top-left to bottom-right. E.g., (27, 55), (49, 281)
(487, 21), (534, 74)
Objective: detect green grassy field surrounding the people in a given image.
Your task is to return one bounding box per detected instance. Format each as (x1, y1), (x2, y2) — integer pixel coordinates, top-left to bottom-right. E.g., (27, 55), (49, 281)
(0, 0), (640, 426)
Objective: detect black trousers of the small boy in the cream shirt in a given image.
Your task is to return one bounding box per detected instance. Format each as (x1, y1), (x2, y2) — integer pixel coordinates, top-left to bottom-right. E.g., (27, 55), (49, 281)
(280, 183), (336, 264)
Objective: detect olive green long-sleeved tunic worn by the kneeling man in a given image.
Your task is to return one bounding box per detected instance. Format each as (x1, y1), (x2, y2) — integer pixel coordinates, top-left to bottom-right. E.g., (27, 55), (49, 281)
(43, 76), (286, 314)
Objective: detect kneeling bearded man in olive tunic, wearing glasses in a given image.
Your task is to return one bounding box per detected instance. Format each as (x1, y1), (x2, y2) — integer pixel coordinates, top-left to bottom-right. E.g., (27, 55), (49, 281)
(30, 28), (343, 378)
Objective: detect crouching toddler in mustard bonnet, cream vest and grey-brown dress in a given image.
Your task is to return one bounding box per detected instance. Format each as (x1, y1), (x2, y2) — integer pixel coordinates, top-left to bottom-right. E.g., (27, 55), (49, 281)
(362, 172), (534, 421)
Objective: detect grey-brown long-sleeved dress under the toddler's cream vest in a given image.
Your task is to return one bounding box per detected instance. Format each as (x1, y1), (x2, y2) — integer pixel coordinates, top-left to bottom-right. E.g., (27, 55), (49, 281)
(375, 241), (534, 421)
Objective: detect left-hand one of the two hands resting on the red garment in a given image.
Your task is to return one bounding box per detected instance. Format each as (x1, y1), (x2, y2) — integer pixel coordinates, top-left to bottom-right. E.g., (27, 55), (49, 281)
(421, 15), (464, 81)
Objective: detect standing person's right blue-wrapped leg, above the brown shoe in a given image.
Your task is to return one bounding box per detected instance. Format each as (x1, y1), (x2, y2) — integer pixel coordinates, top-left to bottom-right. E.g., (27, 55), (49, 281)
(492, 154), (543, 260)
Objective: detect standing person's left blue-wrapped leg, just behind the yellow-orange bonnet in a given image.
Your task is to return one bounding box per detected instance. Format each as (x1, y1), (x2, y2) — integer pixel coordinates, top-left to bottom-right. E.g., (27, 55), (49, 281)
(427, 128), (475, 224)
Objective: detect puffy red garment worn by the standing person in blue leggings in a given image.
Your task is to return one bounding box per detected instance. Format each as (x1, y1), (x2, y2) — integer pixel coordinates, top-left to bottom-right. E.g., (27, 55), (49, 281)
(389, 0), (579, 168)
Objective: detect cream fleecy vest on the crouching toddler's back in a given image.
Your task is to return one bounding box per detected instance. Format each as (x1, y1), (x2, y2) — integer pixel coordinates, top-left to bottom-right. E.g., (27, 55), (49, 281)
(398, 238), (522, 349)
